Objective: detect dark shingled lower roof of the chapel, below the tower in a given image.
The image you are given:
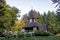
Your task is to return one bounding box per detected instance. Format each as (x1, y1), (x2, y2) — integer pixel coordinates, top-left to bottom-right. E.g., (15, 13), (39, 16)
(23, 22), (47, 30)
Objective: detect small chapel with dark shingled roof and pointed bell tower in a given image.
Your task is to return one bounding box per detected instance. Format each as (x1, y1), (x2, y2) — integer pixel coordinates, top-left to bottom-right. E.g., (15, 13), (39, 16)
(22, 10), (47, 31)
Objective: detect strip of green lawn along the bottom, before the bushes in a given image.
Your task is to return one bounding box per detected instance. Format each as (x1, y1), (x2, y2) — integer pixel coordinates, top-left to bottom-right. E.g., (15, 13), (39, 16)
(0, 36), (60, 40)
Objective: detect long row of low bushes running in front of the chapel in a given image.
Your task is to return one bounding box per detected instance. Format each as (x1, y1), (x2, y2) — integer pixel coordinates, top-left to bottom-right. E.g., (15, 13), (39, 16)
(0, 30), (53, 38)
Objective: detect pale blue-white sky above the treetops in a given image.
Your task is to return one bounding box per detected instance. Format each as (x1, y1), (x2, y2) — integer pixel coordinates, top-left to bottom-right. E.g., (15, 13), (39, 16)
(6, 0), (56, 16)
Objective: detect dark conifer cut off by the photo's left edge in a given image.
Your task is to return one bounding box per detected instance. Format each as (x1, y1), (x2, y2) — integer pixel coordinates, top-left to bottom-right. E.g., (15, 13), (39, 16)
(0, 0), (7, 31)
